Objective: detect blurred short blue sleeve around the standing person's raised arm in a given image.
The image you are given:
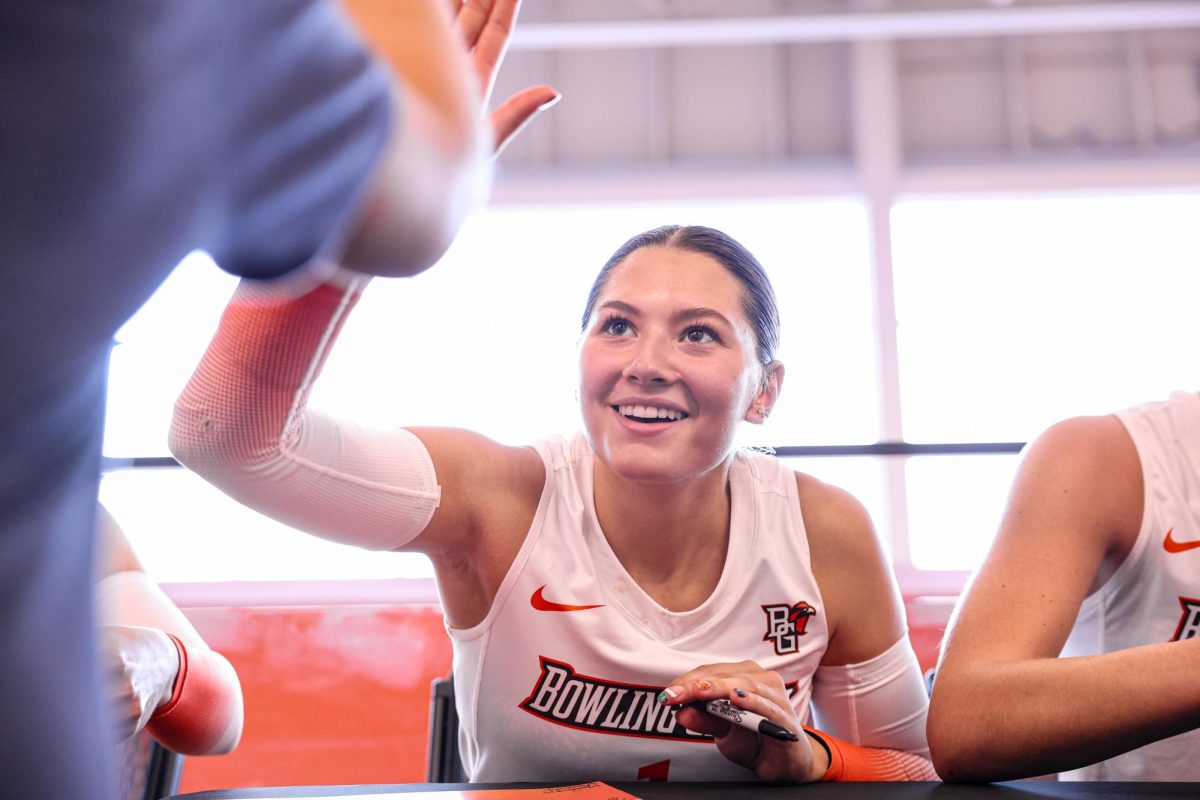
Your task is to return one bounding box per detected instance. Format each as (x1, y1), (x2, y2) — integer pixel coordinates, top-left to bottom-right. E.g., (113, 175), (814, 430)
(211, 0), (394, 278)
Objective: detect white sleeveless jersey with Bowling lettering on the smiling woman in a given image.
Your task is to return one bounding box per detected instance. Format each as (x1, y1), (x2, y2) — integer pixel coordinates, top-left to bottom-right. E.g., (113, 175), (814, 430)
(449, 435), (829, 782)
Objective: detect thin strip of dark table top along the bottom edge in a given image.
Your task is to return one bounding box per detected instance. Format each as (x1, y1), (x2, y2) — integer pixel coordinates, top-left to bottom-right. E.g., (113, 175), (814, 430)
(168, 781), (1200, 800)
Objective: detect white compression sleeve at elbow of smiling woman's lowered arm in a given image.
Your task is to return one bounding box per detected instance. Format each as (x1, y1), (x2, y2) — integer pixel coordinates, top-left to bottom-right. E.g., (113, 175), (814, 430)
(812, 636), (929, 758)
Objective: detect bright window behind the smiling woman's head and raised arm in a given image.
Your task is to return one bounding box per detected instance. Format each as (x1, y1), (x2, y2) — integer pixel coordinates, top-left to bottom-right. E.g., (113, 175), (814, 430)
(102, 200), (878, 582)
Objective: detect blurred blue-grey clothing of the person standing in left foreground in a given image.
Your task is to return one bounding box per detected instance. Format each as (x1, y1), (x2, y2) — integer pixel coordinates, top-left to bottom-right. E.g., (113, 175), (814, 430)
(0, 6), (393, 800)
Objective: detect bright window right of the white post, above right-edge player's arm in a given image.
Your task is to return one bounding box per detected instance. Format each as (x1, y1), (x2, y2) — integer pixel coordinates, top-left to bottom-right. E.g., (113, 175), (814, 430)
(893, 194), (1200, 570)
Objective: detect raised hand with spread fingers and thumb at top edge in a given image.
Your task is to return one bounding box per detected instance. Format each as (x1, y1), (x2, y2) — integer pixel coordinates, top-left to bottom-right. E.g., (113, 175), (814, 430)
(451, 0), (559, 155)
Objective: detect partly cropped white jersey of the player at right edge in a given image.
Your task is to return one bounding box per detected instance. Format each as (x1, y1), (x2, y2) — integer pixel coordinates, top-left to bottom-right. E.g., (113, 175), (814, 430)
(1060, 392), (1200, 781)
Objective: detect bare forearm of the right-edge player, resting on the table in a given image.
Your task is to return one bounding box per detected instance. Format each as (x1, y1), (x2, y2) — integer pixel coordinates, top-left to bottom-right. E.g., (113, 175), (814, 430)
(929, 639), (1200, 781)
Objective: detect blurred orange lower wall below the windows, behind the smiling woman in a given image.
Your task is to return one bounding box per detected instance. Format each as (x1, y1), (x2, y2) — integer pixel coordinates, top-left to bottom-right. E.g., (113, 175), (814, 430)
(168, 588), (942, 792)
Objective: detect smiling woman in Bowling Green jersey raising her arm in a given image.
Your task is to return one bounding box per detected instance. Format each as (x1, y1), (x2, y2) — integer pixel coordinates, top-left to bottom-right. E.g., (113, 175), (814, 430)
(170, 2), (934, 782)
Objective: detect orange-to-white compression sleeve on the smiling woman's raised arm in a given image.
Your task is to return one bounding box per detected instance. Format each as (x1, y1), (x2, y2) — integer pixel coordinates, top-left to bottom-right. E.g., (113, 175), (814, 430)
(170, 281), (440, 549)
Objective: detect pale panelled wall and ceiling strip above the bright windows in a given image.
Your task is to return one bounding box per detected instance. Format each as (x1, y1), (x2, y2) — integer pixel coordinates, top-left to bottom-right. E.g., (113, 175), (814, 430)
(484, 0), (1200, 201)
